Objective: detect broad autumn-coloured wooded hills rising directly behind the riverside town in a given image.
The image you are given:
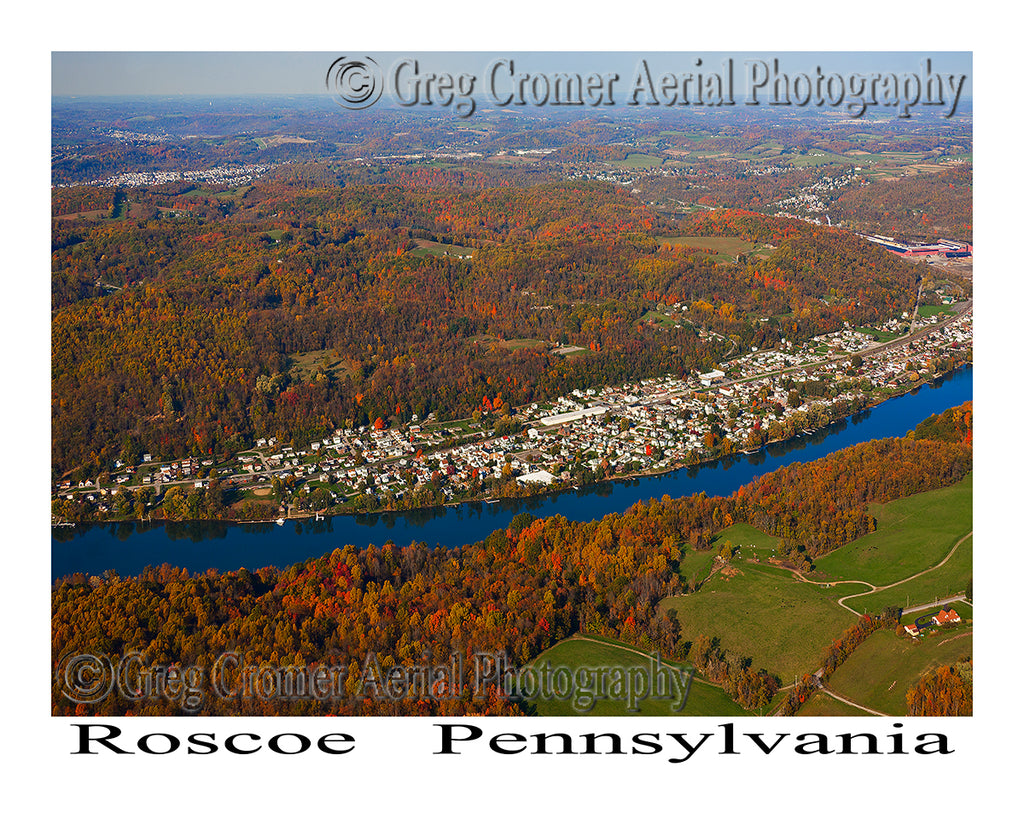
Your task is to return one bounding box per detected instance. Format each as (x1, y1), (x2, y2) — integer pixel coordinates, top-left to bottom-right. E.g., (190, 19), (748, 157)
(51, 174), (914, 479)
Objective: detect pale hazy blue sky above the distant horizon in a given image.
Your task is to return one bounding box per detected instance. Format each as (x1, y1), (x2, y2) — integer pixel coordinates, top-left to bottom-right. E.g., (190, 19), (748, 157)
(51, 51), (973, 98)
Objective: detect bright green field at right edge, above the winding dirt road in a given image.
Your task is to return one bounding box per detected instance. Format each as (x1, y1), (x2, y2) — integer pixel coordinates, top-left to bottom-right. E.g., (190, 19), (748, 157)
(814, 475), (973, 596)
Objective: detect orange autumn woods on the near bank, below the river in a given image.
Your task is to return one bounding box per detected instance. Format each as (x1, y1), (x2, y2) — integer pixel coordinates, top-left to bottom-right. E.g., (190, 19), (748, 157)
(51, 425), (970, 714)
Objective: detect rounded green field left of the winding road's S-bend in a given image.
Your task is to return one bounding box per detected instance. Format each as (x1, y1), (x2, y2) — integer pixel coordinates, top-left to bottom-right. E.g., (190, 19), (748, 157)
(662, 562), (855, 682)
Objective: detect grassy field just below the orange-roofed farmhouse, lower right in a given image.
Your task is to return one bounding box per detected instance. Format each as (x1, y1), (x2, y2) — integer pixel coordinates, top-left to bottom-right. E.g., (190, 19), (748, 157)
(828, 622), (973, 716)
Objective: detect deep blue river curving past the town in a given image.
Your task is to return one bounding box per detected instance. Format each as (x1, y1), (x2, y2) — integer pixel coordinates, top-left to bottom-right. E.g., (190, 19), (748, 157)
(50, 367), (974, 578)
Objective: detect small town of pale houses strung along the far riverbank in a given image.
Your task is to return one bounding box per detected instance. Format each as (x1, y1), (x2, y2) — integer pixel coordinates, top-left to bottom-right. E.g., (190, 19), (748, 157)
(53, 302), (972, 525)
